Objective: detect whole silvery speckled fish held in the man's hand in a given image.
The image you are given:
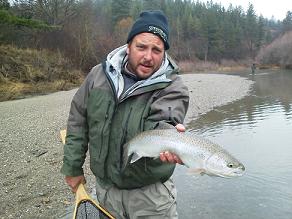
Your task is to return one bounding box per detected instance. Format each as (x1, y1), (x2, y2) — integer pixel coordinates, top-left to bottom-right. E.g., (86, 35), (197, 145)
(123, 129), (245, 178)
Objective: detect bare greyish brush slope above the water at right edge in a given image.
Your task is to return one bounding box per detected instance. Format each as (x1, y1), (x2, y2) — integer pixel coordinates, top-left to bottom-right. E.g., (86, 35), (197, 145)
(257, 31), (292, 69)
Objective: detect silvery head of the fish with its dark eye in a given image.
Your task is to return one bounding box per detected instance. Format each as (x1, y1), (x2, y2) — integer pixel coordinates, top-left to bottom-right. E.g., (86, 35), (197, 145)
(205, 151), (245, 178)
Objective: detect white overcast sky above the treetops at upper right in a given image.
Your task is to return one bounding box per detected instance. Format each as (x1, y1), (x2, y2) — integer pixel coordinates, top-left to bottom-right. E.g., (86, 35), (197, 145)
(201, 0), (292, 20)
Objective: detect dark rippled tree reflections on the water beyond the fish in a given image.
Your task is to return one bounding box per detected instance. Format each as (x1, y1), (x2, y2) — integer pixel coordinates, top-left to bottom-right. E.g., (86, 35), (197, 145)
(189, 71), (292, 135)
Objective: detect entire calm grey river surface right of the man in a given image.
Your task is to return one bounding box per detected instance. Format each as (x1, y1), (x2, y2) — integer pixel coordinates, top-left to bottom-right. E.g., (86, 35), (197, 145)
(174, 70), (292, 219)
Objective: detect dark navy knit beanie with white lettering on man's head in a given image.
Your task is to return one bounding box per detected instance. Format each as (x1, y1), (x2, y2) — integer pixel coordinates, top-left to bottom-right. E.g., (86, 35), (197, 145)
(127, 10), (169, 50)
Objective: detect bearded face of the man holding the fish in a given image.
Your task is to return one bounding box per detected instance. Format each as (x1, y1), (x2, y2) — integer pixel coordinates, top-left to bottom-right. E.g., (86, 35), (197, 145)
(127, 33), (165, 79)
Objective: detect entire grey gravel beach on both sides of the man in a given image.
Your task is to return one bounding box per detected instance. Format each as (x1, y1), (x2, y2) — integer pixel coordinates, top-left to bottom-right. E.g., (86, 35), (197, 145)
(0, 74), (252, 219)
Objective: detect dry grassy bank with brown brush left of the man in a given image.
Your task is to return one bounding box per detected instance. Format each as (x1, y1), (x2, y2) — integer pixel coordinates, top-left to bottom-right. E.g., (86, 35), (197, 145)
(0, 45), (84, 101)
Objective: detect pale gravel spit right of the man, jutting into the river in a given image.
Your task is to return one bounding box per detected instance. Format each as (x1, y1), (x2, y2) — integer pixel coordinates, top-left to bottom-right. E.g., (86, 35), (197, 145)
(182, 73), (253, 125)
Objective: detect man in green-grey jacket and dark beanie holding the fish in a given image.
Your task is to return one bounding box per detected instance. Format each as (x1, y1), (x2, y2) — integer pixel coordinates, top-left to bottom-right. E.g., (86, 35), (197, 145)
(61, 11), (189, 219)
